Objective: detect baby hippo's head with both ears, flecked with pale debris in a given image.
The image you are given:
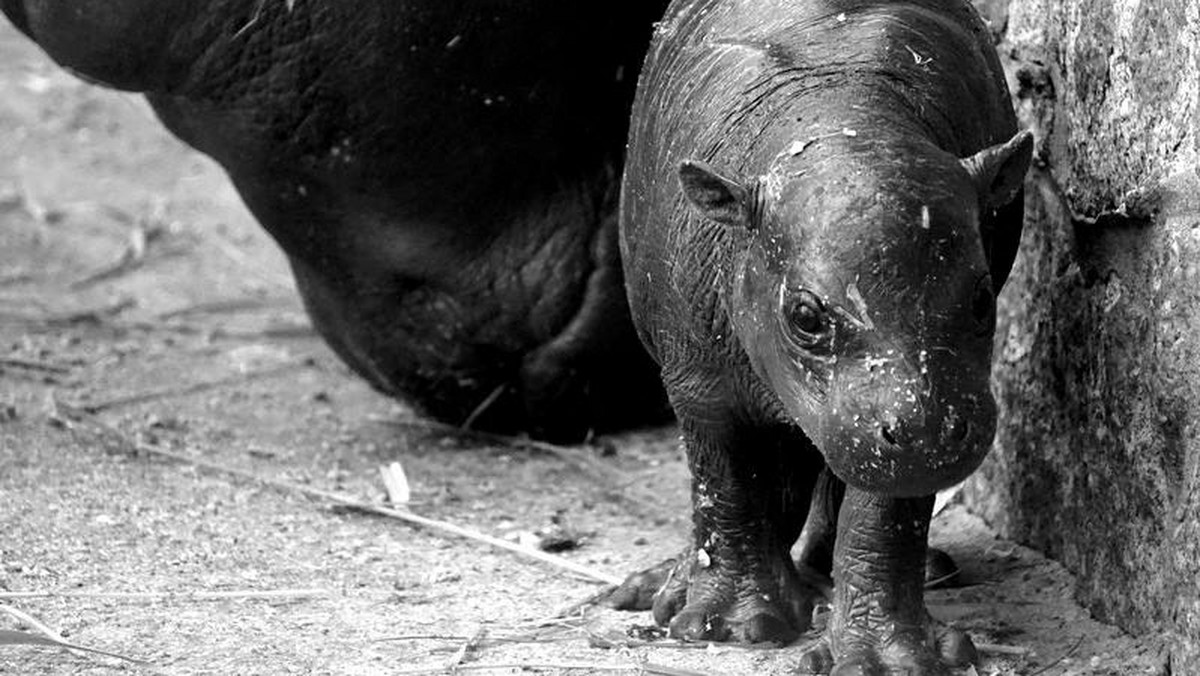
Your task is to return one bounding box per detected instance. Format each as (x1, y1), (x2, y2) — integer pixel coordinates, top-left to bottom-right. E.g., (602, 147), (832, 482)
(680, 132), (1032, 496)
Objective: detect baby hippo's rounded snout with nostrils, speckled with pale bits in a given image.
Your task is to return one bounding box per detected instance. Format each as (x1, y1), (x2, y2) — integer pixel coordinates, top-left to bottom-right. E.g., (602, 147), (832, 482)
(814, 360), (996, 497)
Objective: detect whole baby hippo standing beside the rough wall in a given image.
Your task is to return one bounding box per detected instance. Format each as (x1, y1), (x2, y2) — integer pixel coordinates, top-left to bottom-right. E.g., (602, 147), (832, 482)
(613, 0), (1031, 675)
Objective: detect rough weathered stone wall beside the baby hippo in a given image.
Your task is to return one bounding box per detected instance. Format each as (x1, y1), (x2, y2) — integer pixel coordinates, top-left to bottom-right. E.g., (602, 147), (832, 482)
(965, 0), (1200, 675)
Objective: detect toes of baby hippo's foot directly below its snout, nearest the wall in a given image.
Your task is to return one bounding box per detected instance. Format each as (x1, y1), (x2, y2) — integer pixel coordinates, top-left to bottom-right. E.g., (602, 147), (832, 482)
(797, 621), (978, 676)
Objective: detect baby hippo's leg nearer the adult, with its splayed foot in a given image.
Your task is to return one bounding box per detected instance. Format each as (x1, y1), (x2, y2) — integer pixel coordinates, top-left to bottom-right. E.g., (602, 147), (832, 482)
(611, 418), (821, 644)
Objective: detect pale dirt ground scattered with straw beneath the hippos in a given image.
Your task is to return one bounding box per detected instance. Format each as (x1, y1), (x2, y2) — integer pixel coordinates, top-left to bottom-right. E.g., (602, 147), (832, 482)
(0, 25), (1166, 676)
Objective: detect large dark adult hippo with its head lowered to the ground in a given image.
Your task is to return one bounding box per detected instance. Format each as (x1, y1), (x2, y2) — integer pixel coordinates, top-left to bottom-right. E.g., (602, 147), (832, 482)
(0, 0), (670, 439)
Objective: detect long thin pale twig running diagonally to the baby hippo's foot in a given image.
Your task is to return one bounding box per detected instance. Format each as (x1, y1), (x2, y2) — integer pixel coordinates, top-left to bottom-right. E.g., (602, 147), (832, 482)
(55, 402), (620, 585)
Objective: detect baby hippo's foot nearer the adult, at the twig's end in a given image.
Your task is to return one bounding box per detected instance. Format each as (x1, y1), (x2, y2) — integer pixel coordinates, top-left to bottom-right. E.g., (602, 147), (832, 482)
(610, 548), (820, 645)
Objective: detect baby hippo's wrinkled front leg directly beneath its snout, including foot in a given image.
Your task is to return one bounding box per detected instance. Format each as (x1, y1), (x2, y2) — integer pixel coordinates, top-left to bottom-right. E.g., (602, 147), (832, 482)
(800, 487), (974, 676)
